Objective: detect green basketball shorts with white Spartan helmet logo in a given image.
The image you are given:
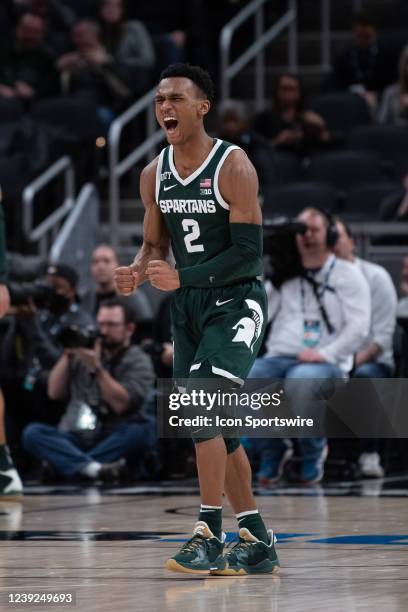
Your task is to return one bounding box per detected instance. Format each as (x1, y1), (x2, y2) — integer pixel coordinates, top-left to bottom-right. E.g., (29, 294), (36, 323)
(171, 280), (267, 384)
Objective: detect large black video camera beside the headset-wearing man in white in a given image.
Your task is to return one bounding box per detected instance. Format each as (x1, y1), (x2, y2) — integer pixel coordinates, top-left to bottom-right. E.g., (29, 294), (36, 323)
(263, 217), (307, 289)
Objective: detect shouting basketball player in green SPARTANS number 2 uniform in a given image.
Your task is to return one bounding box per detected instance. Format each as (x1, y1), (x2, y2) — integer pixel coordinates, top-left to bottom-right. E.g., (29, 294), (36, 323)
(116, 64), (279, 575)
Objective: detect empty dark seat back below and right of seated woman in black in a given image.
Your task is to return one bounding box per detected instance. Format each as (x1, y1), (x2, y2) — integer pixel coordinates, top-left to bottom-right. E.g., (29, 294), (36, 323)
(305, 151), (385, 197)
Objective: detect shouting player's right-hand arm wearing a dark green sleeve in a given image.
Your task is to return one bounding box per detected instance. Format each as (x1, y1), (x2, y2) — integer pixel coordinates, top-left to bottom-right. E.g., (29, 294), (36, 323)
(178, 150), (262, 287)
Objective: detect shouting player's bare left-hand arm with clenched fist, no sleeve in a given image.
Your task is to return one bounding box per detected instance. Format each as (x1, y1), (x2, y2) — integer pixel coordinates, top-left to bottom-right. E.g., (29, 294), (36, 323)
(115, 158), (171, 295)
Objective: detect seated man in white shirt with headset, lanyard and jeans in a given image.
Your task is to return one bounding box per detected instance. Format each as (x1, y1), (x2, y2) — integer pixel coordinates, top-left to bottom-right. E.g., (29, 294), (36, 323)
(250, 208), (370, 484)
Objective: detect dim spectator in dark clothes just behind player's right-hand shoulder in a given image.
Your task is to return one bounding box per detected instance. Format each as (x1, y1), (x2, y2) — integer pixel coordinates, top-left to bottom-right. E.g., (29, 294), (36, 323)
(217, 100), (277, 202)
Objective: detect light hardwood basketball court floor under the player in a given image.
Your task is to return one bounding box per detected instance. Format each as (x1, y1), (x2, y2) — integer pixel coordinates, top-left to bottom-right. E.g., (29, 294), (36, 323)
(0, 476), (408, 612)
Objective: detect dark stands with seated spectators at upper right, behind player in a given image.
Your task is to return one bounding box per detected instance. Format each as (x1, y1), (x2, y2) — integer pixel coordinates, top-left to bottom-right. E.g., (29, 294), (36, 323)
(217, 15), (408, 221)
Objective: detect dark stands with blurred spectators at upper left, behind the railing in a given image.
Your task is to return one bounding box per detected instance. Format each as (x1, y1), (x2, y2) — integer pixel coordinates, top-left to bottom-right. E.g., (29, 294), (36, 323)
(0, 0), (210, 249)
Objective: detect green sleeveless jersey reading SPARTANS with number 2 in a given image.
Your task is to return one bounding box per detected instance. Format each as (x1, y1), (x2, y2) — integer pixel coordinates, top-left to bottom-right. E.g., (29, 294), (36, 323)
(156, 139), (239, 268)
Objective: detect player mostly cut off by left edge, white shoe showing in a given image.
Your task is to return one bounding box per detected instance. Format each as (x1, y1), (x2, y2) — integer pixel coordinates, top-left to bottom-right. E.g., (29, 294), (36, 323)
(0, 201), (23, 496)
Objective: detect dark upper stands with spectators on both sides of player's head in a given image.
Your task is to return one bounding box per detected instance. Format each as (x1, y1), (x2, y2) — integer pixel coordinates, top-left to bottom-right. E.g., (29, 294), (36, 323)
(0, 5), (408, 227)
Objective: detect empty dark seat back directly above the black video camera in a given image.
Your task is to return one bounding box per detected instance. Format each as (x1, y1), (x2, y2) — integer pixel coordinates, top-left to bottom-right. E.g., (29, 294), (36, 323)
(263, 182), (336, 218)
